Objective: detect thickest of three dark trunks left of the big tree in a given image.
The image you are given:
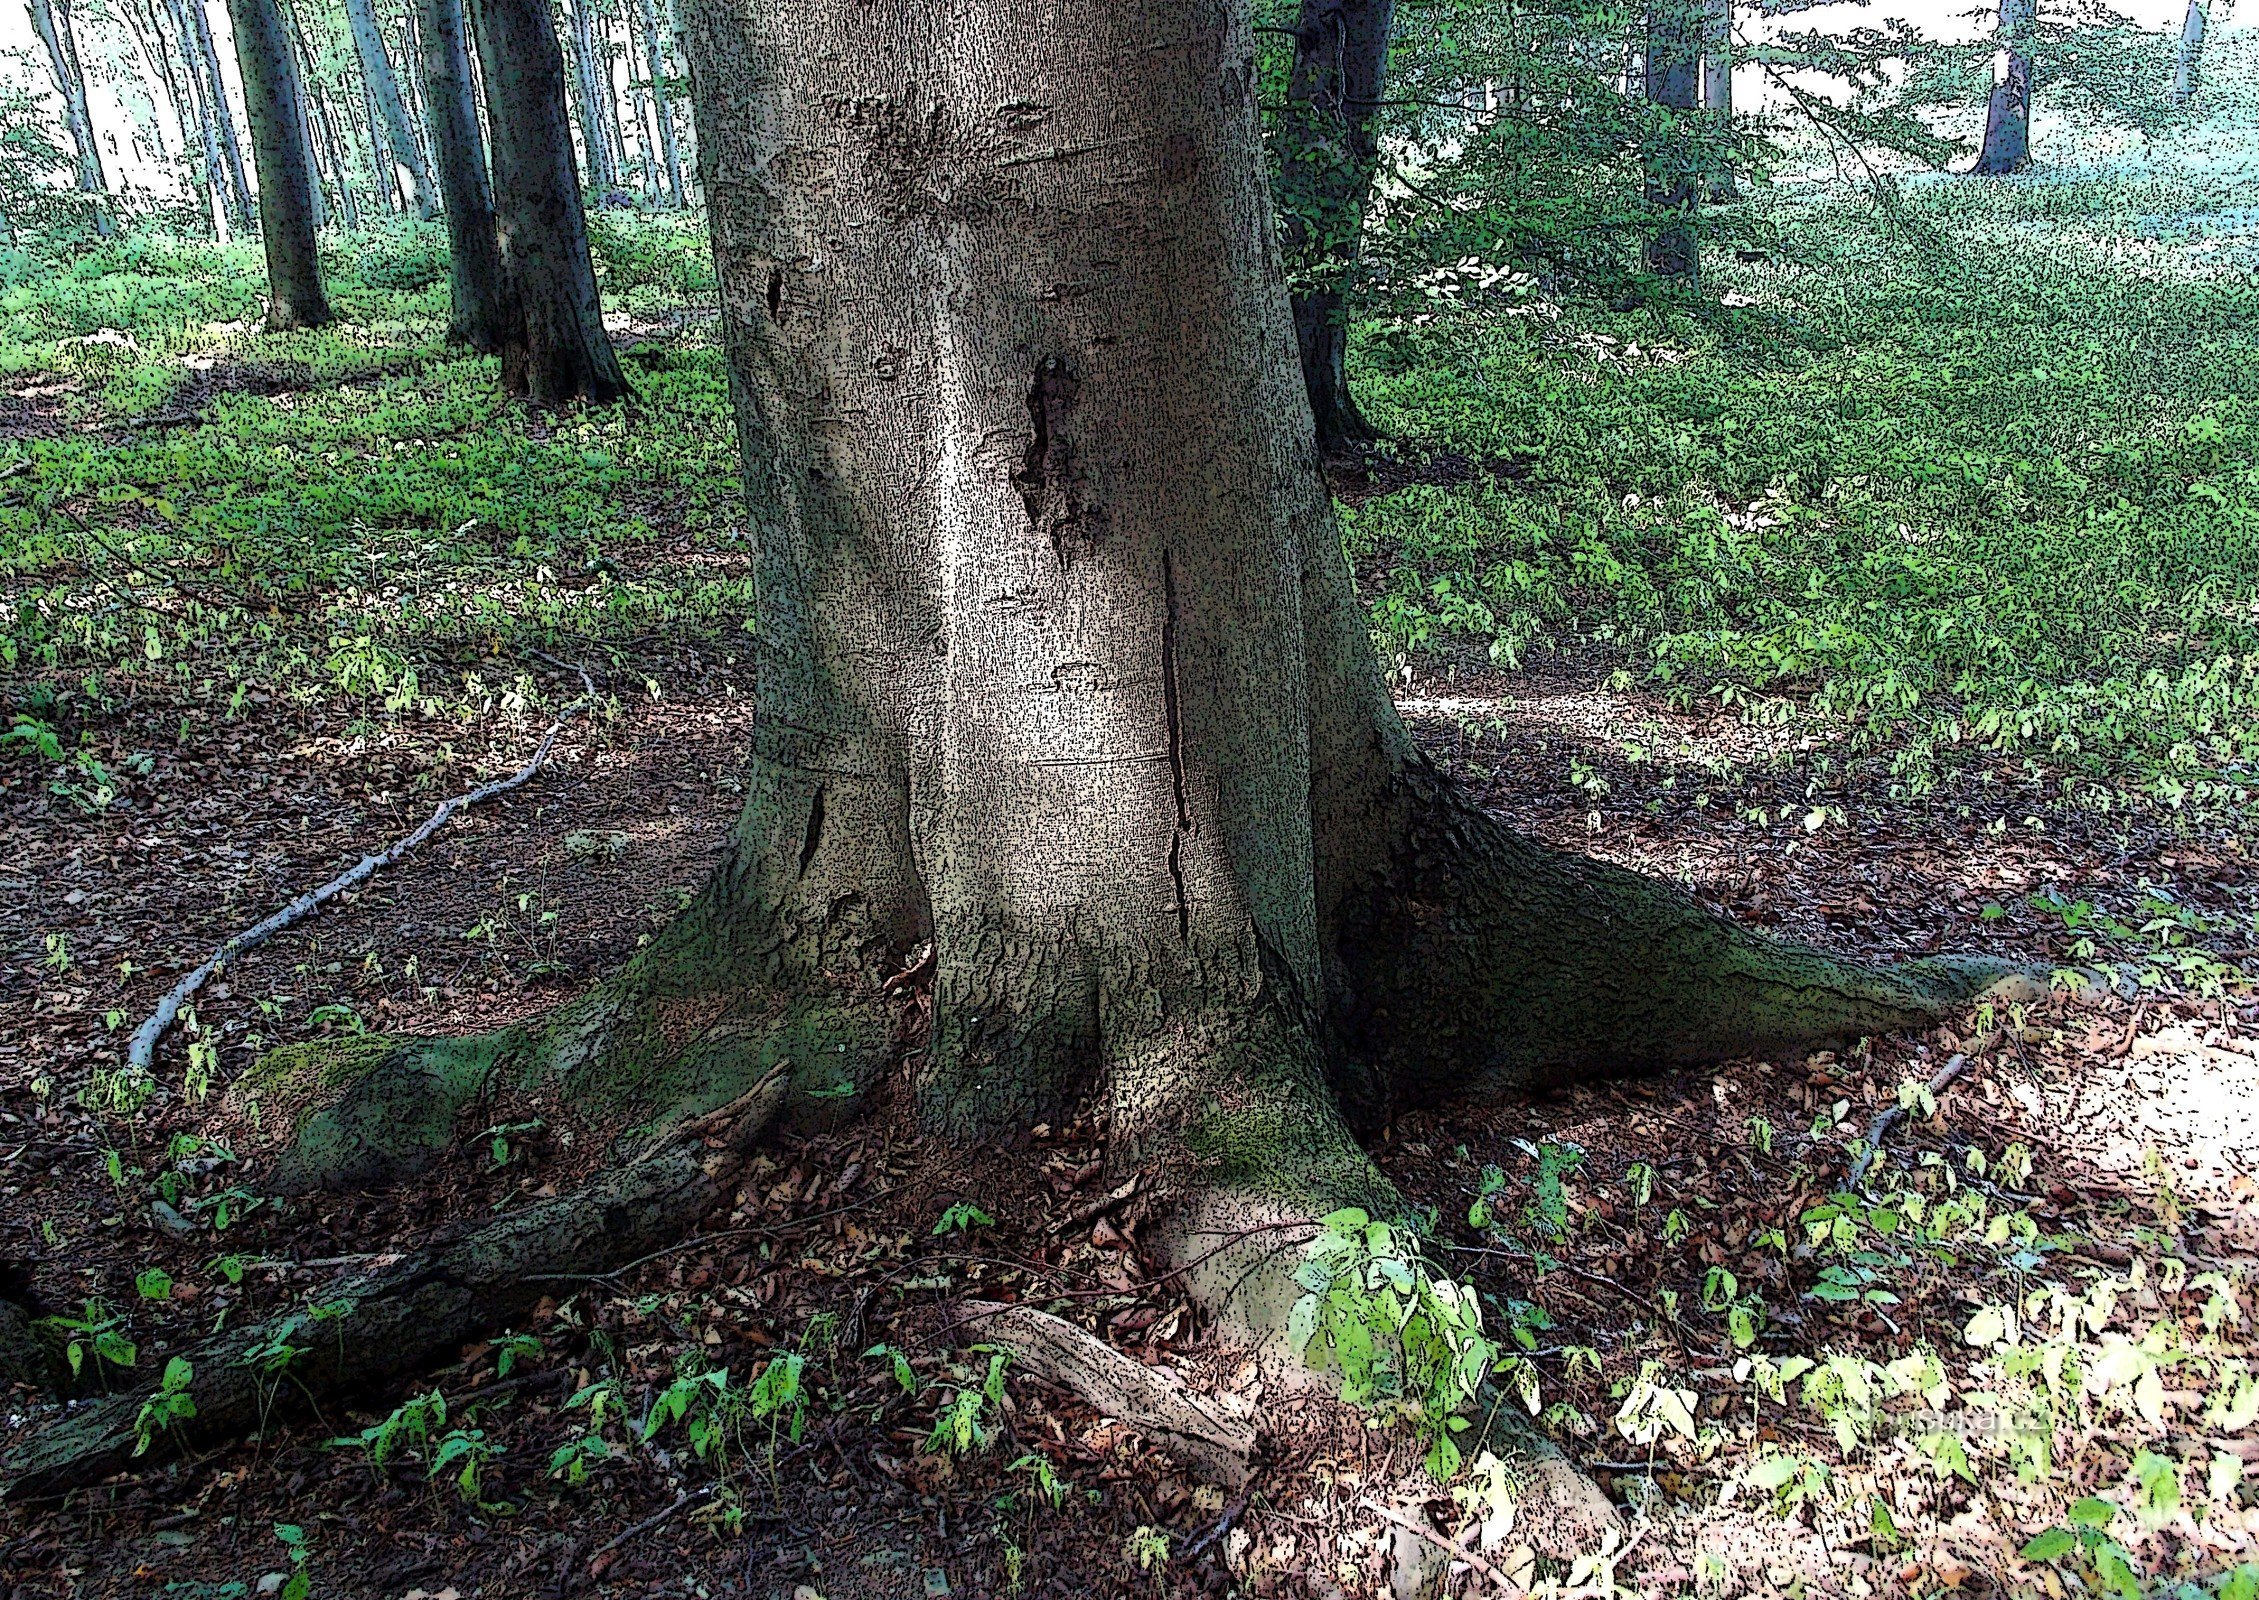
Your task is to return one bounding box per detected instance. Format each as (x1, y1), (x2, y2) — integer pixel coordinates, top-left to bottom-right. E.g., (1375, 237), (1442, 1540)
(472, 0), (628, 407)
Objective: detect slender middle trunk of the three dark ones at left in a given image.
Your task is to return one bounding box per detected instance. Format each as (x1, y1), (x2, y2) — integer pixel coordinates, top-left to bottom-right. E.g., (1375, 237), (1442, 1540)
(416, 0), (513, 343)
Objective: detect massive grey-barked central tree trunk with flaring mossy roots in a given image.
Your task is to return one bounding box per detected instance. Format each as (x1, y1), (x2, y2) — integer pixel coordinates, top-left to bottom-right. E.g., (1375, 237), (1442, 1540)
(22, 0), (2033, 1563)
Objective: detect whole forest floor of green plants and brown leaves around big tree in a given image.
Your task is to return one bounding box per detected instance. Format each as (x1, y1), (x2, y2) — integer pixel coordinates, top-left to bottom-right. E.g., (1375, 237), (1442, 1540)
(0, 128), (2259, 1600)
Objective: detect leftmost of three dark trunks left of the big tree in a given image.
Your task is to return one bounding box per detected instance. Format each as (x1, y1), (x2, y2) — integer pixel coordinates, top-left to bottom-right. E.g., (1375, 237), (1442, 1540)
(227, 0), (330, 332)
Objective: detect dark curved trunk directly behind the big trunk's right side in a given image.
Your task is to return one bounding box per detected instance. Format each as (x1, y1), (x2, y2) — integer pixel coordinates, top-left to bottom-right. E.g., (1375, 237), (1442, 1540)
(1276, 0), (1396, 456)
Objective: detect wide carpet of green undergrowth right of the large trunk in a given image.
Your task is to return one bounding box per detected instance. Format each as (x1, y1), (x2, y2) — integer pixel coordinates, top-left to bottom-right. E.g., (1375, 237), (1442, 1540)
(1349, 128), (2259, 805)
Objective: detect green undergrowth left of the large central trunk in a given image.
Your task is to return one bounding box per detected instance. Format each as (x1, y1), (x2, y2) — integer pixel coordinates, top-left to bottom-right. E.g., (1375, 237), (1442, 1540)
(0, 209), (752, 746)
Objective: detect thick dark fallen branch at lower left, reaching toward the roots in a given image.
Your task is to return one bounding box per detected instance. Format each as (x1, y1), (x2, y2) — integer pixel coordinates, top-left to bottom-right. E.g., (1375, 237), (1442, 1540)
(0, 1069), (788, 1498)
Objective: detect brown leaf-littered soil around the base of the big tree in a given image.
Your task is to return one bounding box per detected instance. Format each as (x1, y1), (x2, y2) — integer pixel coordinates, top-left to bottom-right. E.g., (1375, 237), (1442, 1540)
(0, 546), (2259, 1600)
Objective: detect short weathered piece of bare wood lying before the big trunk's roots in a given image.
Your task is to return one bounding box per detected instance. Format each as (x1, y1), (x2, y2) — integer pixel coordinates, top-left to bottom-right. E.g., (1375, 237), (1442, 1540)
(960, 1299), (1258, 1489)
